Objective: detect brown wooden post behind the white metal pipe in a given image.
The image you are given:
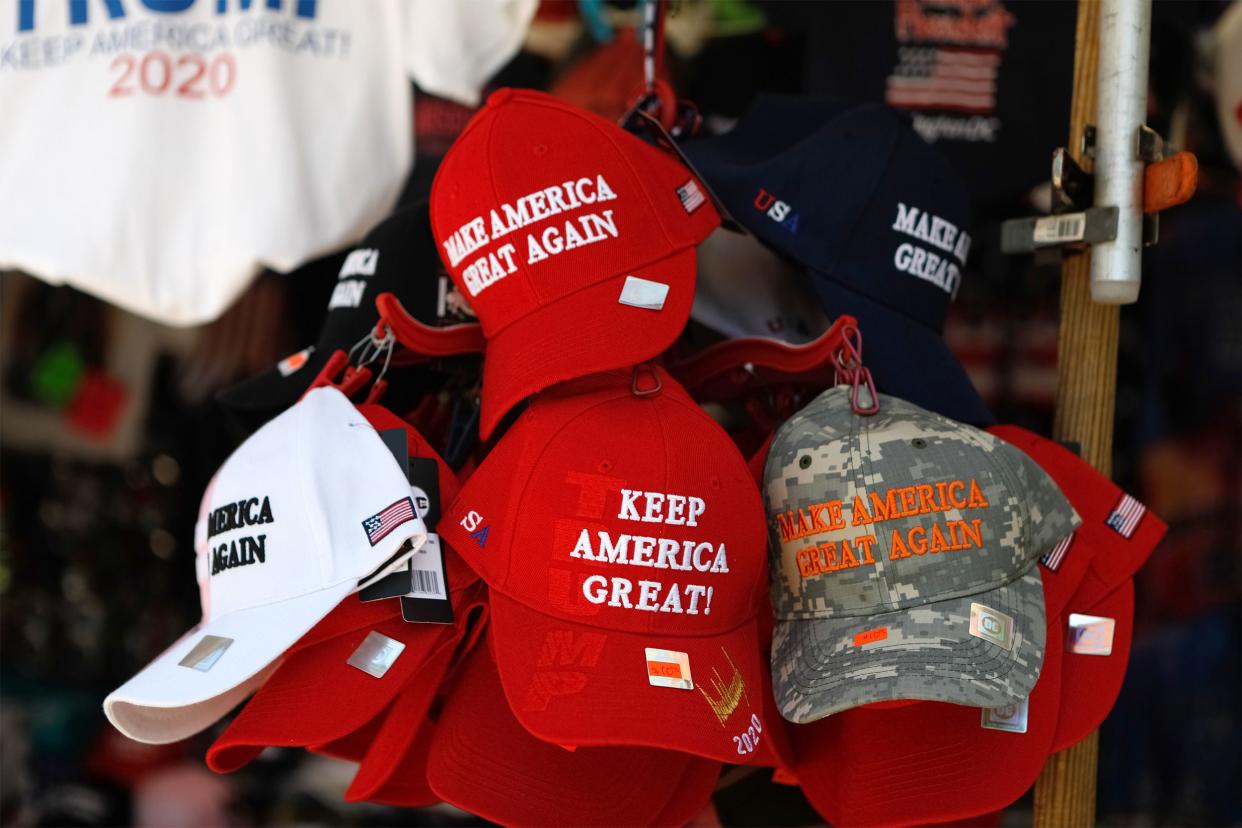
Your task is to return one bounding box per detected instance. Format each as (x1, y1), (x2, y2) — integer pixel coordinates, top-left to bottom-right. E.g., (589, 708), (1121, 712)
(1035, 0), (1119, 828)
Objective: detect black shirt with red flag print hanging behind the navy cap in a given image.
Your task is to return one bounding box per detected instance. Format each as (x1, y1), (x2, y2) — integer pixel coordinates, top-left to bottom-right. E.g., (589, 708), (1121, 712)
(771, 0), (1077, 216)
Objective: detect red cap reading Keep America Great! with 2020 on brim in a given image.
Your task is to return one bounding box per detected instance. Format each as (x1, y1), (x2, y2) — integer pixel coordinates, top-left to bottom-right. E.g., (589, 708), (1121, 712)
(440, 369), (777, 765)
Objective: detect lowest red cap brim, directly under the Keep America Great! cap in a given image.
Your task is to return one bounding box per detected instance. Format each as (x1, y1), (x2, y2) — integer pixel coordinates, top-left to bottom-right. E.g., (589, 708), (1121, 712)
(427, 647), (720, 826)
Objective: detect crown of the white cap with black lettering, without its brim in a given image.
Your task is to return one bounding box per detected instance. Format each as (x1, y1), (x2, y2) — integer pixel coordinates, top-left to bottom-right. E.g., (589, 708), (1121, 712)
(195, 389), (426, 622)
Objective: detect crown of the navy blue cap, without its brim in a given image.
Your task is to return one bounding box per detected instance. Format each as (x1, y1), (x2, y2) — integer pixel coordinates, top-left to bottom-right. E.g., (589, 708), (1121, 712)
(684, 96), (971, 331)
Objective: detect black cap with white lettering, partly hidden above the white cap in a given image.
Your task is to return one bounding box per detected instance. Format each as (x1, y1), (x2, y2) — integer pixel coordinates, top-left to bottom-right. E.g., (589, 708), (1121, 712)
(216, 201), (457, 426)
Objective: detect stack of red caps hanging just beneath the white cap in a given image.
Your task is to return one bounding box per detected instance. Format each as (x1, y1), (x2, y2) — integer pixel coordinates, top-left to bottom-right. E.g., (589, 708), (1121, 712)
(207, 405), (486, 806)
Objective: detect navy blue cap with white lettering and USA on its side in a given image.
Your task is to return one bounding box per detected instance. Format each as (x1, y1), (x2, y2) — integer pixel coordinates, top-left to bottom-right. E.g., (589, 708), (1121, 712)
(682, 96), (994, 426)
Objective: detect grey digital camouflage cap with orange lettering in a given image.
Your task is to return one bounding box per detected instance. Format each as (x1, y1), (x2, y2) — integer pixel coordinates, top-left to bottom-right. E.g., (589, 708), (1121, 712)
(764, 386), (1082, 724)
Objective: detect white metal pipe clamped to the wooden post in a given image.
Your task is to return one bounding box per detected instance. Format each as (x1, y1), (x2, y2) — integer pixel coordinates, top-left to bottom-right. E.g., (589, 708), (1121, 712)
(1090, 0), (1151, 304)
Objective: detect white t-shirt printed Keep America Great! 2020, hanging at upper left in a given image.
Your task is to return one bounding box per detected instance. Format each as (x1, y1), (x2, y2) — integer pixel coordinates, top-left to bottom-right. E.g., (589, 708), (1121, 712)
(0, 0), (537, 325)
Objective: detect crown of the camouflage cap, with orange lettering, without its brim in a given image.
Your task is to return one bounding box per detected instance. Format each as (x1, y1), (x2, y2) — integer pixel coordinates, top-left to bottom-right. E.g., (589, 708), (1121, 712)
(764, 386), (1081, 619)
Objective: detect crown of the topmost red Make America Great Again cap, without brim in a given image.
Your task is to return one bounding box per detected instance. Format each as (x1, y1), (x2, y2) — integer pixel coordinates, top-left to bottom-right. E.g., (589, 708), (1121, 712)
(431, 89), (719, 336)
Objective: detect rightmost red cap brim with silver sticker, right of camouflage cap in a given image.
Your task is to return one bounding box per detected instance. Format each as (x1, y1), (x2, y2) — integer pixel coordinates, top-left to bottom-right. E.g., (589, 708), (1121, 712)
(1049, 581), (1134, 752)
